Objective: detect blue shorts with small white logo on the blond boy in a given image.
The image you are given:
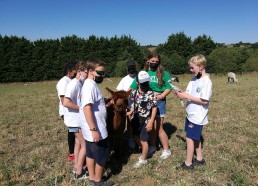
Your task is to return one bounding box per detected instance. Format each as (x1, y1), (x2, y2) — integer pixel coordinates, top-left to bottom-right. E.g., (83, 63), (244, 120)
(185, 118), (203, 141)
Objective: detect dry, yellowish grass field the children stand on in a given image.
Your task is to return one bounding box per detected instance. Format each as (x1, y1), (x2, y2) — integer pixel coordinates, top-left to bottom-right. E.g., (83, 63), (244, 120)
(0, 73), (258, 185)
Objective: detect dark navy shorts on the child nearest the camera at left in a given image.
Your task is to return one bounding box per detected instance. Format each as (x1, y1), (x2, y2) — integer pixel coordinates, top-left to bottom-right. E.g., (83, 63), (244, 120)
(86, 138), (110, 166)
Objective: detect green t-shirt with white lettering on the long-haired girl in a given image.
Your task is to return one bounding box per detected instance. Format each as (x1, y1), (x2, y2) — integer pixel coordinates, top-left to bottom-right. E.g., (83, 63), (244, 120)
(130, 70), (173, 92)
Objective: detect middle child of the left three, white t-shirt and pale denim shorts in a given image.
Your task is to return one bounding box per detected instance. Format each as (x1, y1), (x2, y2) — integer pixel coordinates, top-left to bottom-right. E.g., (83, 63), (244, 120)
(63, 61), (88, 179)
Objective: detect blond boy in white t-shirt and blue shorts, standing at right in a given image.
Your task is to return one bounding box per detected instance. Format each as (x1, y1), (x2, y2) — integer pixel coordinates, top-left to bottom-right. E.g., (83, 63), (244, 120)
(175, 55), (212, 170)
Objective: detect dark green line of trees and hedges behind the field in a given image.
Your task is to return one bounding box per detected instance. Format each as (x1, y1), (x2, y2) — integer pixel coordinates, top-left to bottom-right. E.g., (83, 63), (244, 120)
(0, 32), (258, 82)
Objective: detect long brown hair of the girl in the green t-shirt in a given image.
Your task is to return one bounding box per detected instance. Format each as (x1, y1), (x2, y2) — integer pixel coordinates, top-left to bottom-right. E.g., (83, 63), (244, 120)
(144, 51), (164, 86)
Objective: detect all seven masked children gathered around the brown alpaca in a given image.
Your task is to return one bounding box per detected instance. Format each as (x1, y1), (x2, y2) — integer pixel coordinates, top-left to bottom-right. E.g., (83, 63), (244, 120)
(57, 52), (212, 185)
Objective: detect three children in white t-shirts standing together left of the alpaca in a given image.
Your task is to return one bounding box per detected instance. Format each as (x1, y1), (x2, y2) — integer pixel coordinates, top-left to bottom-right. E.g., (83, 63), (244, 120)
(56, 59), (109, 185)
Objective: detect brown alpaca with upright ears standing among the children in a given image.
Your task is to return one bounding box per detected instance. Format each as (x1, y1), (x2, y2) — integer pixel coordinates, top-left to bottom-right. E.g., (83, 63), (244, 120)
(106, 87), (131, 156)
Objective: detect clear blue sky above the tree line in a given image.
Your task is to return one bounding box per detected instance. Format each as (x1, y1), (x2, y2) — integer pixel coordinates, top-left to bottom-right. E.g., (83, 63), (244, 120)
(0, 0), (258, 45)
